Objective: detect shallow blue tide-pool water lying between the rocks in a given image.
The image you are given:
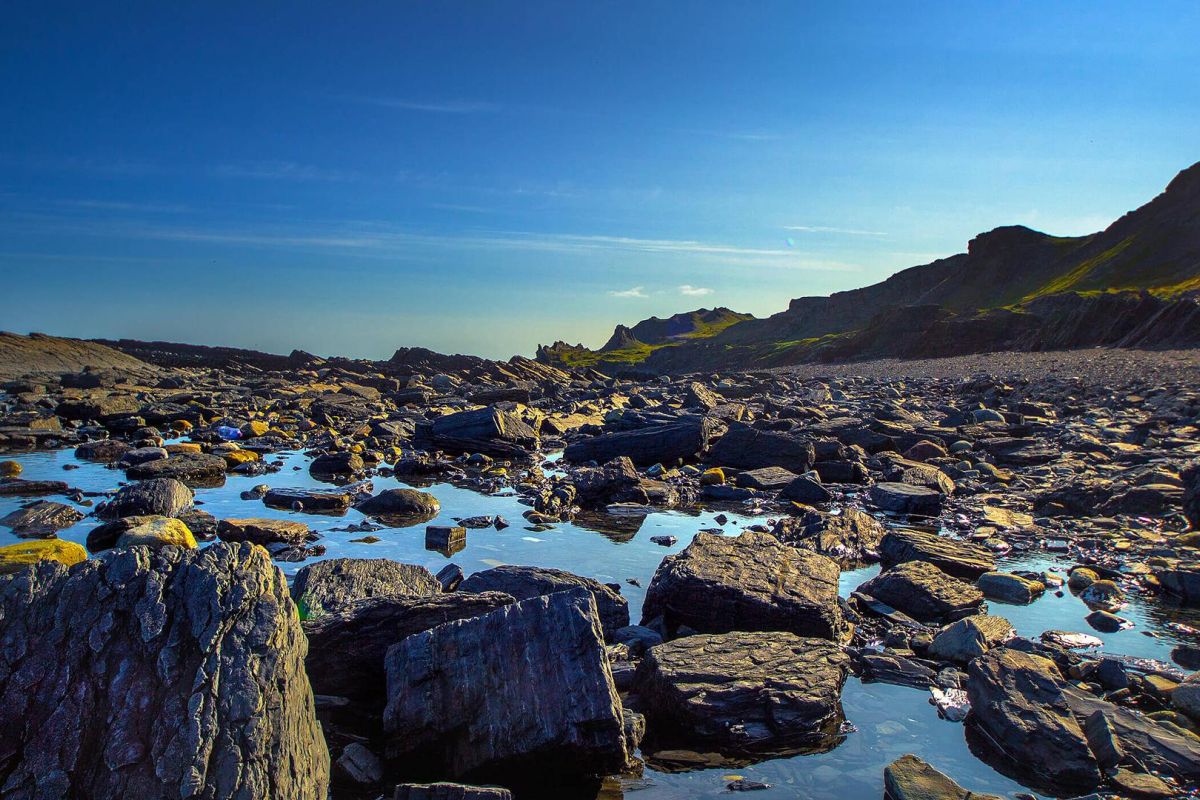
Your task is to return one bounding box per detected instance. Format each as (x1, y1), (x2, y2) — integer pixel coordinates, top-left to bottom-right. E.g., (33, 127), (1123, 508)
(0, 450), (1200, 800)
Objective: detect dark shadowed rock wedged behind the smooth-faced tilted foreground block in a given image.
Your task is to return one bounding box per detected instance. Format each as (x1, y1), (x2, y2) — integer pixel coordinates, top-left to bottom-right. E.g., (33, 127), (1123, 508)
(304, 591), (516, 711)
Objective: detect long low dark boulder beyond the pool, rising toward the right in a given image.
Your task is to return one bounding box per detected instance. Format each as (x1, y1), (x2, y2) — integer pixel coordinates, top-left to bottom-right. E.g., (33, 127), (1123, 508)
(563, 415), (721, 467)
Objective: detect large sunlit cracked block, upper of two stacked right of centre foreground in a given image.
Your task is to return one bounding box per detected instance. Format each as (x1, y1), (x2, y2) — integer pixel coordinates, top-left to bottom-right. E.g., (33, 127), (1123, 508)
(642, 531), (846, 639)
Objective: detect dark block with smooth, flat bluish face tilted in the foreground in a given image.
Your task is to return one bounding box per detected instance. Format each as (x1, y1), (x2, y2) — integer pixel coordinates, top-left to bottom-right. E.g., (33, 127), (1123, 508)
(384, 589), (629, 781)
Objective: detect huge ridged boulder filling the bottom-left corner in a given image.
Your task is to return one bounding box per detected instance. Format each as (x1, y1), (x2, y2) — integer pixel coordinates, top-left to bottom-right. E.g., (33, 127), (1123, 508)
(0, 545), (329, 800)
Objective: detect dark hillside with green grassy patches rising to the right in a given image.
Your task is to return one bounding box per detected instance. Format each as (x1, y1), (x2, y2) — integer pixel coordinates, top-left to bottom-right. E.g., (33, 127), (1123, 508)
(539, 164), (1200, 373)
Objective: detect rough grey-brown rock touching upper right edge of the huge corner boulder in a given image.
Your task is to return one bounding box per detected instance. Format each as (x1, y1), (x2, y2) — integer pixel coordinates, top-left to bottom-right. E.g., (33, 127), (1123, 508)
(292, 559), (442, 618)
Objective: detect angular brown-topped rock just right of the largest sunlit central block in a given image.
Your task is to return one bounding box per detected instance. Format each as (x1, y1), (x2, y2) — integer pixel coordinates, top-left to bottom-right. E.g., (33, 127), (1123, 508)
(857, 561), (983, 622)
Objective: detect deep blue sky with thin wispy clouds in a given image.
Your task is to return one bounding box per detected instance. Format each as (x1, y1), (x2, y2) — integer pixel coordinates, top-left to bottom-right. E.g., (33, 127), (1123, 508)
(0, 0), (1200, 357)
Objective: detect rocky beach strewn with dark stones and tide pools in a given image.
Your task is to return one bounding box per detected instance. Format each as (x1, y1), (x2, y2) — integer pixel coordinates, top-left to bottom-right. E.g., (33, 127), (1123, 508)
(0, 335), (1200, 800)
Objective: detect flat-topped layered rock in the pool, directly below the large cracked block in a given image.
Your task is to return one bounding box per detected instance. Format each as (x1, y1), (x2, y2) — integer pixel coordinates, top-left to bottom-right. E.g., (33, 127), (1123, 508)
(635, 631), (850, 752)
